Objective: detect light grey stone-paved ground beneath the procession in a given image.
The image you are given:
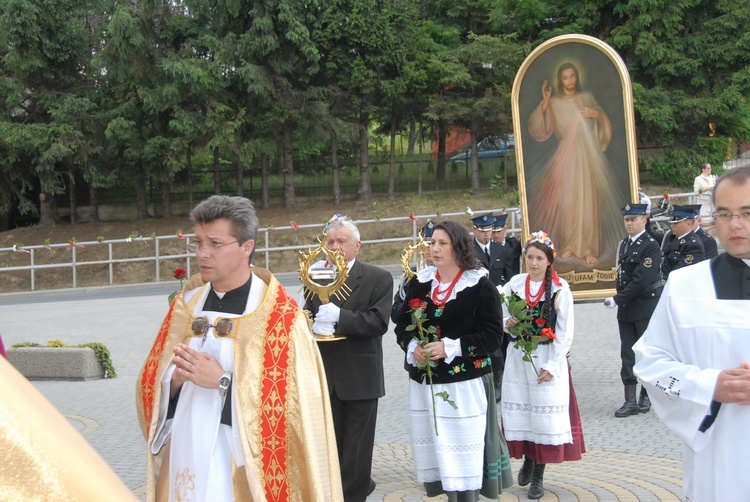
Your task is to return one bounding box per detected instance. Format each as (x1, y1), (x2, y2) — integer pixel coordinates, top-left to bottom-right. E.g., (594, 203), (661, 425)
(0, 275), (682, 502)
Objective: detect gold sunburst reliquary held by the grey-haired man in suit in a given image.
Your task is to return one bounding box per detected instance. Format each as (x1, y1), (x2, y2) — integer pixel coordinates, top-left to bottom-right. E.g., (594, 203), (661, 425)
(299, 239), (351, 342)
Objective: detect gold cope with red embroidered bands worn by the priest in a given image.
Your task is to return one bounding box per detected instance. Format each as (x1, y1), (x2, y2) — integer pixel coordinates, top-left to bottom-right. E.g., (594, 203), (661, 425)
(136, 267), (341, 501)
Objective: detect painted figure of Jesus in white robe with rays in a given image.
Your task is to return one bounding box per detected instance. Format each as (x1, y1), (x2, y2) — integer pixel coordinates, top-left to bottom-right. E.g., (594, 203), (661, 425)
(528, 62), (623, 265)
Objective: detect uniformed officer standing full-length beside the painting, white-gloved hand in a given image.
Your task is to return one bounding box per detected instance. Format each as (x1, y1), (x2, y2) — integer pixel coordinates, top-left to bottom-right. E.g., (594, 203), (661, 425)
(604, 204), (662, 418)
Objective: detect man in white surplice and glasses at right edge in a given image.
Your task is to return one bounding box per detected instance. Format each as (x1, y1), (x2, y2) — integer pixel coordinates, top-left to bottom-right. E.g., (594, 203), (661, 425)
(633, 168), (750, 502)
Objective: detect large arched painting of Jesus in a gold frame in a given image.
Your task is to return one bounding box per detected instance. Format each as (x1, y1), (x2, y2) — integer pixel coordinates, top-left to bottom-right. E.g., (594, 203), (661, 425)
(513, 35), (639, 298)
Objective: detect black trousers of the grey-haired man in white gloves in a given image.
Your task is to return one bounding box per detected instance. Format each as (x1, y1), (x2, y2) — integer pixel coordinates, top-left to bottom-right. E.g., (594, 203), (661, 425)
(331, 391), (378, 502)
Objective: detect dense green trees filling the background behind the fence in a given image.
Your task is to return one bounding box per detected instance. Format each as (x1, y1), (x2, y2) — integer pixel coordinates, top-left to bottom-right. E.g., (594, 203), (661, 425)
(0, 0), (750, 222)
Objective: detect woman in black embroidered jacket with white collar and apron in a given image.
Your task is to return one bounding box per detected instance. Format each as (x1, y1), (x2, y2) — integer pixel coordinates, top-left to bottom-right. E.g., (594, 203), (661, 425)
(396, 221), (513, 502)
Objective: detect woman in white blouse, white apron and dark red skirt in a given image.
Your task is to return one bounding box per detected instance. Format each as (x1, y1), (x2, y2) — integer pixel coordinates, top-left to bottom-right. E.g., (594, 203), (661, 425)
(501, 231), (586, 499)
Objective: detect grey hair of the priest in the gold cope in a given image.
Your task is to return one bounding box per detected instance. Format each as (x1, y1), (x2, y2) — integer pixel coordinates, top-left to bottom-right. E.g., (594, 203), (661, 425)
(190, 195), (260, 244)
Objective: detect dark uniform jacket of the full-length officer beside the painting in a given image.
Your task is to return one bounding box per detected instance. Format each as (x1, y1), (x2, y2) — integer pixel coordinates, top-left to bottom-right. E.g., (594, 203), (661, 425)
(614, 232), (662, 322)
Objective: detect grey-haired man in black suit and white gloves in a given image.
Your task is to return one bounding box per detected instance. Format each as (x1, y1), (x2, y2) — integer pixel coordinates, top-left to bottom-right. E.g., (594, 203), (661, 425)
(302, 215), (393, 502)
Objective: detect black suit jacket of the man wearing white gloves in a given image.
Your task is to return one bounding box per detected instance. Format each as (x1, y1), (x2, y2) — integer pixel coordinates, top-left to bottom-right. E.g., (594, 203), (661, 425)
(305, 260), (393, 401)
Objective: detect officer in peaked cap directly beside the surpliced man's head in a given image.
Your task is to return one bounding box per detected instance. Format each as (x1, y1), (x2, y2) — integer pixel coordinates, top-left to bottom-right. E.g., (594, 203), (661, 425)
(661, 206), (705, 280)
